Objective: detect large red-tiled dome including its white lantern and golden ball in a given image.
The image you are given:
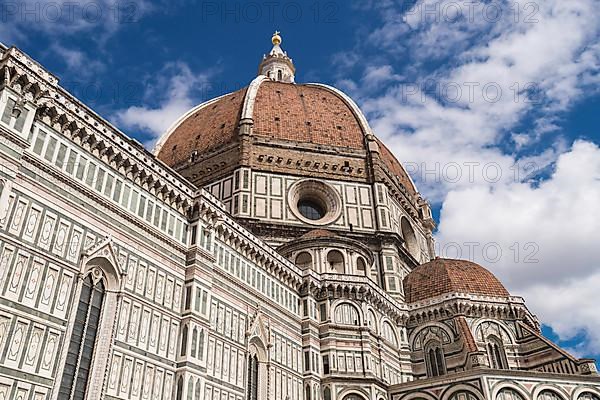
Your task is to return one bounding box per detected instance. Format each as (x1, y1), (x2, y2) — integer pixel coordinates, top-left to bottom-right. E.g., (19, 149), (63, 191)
(154, 35), (417, 199)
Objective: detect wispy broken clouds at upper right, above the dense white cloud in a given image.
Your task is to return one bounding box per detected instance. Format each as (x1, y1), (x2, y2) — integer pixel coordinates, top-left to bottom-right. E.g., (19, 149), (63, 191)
(356, 0), (600, 197)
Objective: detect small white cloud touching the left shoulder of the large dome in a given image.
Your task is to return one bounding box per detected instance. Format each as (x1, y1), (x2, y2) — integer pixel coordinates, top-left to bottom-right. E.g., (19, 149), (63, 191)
(114, 62), (214, 147)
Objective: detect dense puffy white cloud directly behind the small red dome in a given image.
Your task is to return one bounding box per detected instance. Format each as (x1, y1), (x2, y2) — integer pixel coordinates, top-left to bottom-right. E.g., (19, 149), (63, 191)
(436, 141), (600, 353)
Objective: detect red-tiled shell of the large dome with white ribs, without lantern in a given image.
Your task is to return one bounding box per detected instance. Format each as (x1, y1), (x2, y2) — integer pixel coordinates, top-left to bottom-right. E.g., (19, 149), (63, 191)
(155, 75), (417, 195)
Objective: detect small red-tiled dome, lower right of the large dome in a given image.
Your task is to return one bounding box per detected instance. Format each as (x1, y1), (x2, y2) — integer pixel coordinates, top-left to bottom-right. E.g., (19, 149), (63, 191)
(404, 258), (510, 303)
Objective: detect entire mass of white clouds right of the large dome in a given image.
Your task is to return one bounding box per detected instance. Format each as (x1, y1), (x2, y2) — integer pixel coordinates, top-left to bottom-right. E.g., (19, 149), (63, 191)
(346, 0), (600, 354)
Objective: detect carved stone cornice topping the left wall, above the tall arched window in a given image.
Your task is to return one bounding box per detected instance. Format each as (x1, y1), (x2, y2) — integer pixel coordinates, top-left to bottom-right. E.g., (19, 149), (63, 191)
(0, 47), (195, 213)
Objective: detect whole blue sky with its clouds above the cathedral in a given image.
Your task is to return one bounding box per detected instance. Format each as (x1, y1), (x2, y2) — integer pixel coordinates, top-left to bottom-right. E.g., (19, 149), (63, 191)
(0, 0), (600, 364)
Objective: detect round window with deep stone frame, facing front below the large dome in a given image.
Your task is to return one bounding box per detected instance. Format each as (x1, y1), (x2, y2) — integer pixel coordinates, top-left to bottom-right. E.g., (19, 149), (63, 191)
(288, 179), (342, 225)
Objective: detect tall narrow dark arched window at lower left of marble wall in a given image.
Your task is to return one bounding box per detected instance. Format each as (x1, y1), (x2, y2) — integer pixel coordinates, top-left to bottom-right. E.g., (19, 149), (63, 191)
(58, 274), (105, 400)
